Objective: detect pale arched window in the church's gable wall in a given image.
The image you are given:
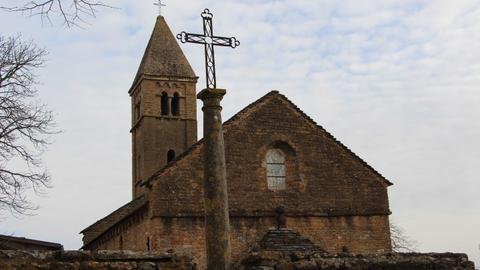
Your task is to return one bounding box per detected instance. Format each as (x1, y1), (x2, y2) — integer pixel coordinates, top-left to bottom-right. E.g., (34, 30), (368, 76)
(265, 148), (286, 190)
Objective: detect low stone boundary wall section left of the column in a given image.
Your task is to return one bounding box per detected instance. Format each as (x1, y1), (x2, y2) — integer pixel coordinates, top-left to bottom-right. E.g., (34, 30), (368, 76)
(0, 250), (197, 270)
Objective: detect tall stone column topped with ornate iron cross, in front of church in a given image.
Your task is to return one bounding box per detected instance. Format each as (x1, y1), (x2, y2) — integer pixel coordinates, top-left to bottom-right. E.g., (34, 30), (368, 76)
(177, 9), (240, 270)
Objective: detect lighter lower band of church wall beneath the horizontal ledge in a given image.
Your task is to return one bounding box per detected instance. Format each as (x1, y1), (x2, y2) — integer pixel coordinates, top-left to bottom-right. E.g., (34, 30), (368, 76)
(103, 216), (390, 269)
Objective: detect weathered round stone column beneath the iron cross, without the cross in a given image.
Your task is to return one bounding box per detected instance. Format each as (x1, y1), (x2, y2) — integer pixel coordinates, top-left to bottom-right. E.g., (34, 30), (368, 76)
(197, 89), (231, 270)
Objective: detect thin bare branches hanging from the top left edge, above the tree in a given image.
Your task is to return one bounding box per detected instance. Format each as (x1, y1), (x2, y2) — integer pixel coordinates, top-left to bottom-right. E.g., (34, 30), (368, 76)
(0, 0), (113, 27)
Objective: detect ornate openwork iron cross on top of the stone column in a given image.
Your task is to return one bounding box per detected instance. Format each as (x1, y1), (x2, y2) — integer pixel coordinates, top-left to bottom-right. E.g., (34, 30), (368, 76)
(177, 9), (240, 89)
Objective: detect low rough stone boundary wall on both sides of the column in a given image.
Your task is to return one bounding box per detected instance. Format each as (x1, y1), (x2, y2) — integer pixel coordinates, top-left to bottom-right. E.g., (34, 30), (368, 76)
(0, 251), (474, 270)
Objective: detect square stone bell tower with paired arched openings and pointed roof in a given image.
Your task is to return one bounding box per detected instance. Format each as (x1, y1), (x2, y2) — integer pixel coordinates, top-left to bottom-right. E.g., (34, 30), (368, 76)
(128, 16), (198, 199)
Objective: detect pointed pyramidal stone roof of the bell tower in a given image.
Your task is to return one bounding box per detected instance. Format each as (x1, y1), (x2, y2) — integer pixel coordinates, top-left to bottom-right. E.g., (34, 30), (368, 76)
(130, 16), (197, 91)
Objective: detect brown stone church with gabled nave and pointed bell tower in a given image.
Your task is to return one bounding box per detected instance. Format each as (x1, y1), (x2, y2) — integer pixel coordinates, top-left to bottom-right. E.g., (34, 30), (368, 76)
(81, 16), (391, 268)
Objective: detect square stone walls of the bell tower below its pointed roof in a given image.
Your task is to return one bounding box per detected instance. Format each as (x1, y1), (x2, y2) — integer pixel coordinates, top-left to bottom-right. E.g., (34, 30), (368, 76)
(131, 79), (197, 198)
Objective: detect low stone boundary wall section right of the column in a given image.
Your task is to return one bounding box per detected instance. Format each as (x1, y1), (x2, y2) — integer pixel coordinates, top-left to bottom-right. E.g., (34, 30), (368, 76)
(235, 251), (475, 270)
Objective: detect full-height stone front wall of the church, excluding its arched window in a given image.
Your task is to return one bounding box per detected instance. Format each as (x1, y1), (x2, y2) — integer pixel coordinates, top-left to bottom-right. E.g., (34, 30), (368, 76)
(141, 92), (391, 265)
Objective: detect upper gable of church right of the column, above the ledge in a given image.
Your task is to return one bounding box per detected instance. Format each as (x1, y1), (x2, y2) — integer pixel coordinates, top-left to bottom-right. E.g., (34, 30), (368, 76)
(225, 92), (389, 215)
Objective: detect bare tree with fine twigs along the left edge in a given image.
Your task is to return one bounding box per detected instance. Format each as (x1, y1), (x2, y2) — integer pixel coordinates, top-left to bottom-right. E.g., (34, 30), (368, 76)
(0, 36), (57, 214)
